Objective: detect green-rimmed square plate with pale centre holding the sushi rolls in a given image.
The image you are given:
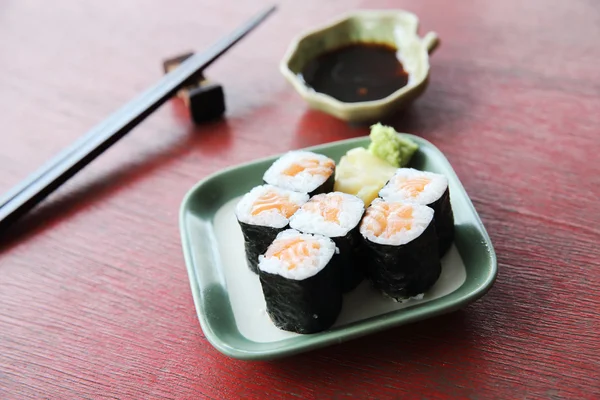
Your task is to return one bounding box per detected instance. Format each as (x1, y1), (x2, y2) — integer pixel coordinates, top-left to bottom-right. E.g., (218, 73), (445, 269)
(180, 135), (497, 360)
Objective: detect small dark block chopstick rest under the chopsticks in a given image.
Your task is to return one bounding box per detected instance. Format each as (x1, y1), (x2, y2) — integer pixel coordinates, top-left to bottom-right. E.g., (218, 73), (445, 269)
(163, 52), (226, 124)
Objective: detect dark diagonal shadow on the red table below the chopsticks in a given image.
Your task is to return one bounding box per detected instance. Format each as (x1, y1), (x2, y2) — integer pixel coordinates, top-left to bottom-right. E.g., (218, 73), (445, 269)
(0, 115), (231, 253)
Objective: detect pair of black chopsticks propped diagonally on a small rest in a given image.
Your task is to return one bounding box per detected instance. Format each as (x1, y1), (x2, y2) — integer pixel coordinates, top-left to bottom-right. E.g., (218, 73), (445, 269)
(0, 6), (276, 231)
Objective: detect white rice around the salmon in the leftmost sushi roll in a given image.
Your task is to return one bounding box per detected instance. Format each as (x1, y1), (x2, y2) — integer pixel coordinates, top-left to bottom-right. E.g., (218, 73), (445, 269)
(235, 185), (309, 228)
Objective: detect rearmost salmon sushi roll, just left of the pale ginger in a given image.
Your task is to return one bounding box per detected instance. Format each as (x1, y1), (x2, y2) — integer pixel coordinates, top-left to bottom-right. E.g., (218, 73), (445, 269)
(263, 151), (335, 196)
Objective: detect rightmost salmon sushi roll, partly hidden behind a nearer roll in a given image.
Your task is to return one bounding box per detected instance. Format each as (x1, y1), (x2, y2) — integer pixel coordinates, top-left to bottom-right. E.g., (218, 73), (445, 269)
(379, 168), (454, 257)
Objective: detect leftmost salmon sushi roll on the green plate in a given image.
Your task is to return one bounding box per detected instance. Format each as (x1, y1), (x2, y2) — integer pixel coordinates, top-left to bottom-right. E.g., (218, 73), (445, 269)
(235, 185), (308, 273)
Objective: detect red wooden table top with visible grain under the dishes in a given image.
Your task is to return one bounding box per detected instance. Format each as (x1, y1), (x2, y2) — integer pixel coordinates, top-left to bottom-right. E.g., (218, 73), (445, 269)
(0, 0), (600, 399)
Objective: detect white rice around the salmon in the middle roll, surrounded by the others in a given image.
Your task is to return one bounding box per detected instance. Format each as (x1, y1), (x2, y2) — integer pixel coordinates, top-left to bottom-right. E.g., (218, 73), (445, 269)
(290, 192), (365, 237)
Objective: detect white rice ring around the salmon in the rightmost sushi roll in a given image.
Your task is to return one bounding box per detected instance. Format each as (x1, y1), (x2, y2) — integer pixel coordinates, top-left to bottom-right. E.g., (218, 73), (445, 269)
(379, 168), (448, 205)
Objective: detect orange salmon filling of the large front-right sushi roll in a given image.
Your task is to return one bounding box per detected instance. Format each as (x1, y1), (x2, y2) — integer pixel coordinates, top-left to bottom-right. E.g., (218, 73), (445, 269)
(364, 203), (413, 238)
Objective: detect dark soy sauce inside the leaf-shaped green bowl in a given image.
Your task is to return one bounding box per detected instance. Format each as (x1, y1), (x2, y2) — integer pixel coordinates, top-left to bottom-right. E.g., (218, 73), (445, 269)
(301, 43), (408, 103)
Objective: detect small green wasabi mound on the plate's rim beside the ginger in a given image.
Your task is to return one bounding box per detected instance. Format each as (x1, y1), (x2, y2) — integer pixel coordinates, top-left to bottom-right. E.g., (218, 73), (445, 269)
(369, 123), (419, 168)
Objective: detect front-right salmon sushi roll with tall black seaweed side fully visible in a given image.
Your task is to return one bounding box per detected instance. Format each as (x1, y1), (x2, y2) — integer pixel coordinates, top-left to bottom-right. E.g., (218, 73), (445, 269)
(360, 199), (442, 301)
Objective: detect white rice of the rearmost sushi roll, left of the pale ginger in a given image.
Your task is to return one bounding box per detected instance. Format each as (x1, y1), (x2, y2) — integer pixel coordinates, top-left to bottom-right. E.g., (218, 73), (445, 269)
(263, 151), (333, 193)
